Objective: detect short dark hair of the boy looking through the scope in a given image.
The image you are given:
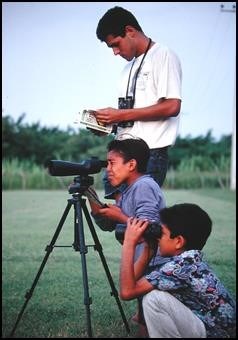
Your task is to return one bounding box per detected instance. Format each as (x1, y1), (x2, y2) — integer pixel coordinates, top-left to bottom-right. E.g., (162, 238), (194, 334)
(107, 138), (150, 173)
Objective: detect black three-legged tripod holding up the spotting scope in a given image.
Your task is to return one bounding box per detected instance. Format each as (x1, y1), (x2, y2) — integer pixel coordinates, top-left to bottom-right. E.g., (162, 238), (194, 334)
(10, 175), (130, 338)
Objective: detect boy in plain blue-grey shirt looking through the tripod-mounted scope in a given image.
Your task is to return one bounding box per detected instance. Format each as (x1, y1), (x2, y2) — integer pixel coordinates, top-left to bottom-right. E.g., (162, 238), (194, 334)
(86, 138), (166, 332)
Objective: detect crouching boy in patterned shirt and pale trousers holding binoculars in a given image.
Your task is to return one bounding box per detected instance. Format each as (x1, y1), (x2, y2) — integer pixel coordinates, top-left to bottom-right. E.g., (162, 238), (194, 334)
(120, 203), (236, 338)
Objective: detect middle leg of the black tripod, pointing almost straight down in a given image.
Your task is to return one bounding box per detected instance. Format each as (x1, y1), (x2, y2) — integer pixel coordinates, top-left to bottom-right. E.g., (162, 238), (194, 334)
(74, 198), (92, 338)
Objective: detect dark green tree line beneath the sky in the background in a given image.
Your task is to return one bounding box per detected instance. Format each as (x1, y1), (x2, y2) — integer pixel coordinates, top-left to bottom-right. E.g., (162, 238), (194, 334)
(2, 114), (231, 171)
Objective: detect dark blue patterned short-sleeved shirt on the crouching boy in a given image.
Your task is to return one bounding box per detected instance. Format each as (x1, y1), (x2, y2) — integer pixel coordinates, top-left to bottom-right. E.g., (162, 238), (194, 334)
(146, 250), (236, 338)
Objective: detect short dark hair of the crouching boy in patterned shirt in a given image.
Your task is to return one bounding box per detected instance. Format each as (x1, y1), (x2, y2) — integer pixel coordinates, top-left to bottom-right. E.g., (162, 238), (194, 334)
(160, 203), (212, 250)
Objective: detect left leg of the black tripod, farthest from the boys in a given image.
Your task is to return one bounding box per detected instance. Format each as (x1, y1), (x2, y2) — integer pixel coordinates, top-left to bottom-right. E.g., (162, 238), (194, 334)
(9, 199), (72, 338)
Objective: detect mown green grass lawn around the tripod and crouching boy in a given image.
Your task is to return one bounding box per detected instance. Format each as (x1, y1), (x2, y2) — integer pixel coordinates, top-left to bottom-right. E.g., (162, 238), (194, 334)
(2, 189), (236, 338)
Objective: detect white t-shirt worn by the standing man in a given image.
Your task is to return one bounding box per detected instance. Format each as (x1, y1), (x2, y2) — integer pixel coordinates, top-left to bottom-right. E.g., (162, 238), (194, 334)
(116, 43), (182, 149)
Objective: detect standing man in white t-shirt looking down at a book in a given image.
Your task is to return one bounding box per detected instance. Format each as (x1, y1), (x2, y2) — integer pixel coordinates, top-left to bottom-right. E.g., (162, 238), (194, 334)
(92, 6), (182, 198)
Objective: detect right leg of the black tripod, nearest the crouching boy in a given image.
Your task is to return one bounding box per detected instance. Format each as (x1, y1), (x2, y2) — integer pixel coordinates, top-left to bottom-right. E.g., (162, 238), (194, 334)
(81, 199), (130, 333)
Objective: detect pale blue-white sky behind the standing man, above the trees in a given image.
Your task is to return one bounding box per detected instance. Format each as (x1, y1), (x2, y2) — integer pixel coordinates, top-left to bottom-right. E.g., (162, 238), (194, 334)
(2, 2), (236, 138)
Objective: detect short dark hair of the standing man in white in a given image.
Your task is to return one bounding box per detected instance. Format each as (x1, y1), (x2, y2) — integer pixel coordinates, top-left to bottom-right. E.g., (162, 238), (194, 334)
(96, 6), (142, 41)
